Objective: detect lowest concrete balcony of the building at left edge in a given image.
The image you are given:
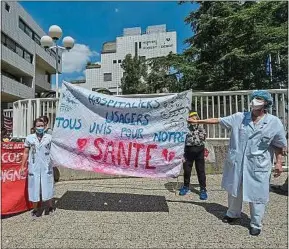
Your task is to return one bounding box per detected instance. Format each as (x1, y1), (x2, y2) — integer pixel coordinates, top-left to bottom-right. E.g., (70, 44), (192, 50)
(1, 74), (34, 102)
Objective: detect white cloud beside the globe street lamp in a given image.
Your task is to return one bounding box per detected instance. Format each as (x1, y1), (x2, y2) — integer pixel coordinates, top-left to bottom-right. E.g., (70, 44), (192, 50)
(62, 43), (99, 73)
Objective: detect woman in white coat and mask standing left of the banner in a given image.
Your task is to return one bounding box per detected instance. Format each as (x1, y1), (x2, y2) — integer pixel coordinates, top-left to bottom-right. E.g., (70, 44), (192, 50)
(20, 118), (54, 217)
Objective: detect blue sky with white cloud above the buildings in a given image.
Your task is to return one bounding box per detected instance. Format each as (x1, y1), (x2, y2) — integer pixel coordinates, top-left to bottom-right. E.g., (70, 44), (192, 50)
(20, 1), (196, 86)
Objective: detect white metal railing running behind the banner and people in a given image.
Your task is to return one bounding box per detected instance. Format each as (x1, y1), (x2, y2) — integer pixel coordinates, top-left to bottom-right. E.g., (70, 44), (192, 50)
(9, 89), (288, 140)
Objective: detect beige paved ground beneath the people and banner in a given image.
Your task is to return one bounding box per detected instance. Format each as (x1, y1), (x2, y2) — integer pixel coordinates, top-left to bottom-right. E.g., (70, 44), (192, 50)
(2, 173), (288, 248)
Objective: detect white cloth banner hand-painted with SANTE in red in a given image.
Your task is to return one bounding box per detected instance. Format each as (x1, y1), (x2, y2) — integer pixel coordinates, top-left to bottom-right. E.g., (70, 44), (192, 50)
(51, 82), (192, 178)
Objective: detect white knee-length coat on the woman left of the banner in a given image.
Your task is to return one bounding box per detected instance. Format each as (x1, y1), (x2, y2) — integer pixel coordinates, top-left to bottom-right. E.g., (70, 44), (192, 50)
(24, 134), (54, 202)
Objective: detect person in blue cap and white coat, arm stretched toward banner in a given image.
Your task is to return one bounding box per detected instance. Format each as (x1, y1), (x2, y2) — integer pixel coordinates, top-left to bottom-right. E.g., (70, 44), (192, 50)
(188, 90), (286, 236)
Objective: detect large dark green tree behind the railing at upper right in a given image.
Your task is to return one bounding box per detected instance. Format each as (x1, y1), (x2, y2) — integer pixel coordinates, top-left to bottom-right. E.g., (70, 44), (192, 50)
(177, 1), (288, 91)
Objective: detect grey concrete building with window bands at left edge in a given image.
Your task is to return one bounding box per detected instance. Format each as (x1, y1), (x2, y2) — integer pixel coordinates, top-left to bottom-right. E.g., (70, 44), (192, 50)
(1, 1), (61, 109)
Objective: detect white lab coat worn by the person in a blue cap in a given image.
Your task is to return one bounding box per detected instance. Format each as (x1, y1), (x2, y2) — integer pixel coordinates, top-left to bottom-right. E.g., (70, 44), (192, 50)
(220, 112), (286, 203)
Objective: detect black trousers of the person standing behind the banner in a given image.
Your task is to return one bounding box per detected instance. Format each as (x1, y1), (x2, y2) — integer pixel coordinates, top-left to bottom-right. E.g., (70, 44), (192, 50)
(183, 146), (206, 189)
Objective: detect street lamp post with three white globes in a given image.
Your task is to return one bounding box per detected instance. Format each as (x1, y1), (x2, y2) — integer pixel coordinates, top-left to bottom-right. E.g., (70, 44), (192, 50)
(40, 25), (74, 98)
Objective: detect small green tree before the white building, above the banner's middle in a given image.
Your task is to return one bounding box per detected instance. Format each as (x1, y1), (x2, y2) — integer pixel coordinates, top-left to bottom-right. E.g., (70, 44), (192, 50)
(121, 54), (147, 94)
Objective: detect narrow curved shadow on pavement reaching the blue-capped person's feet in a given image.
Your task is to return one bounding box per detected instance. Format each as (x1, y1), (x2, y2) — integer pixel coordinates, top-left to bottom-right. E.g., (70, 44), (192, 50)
(167, 200), (250, 228)
